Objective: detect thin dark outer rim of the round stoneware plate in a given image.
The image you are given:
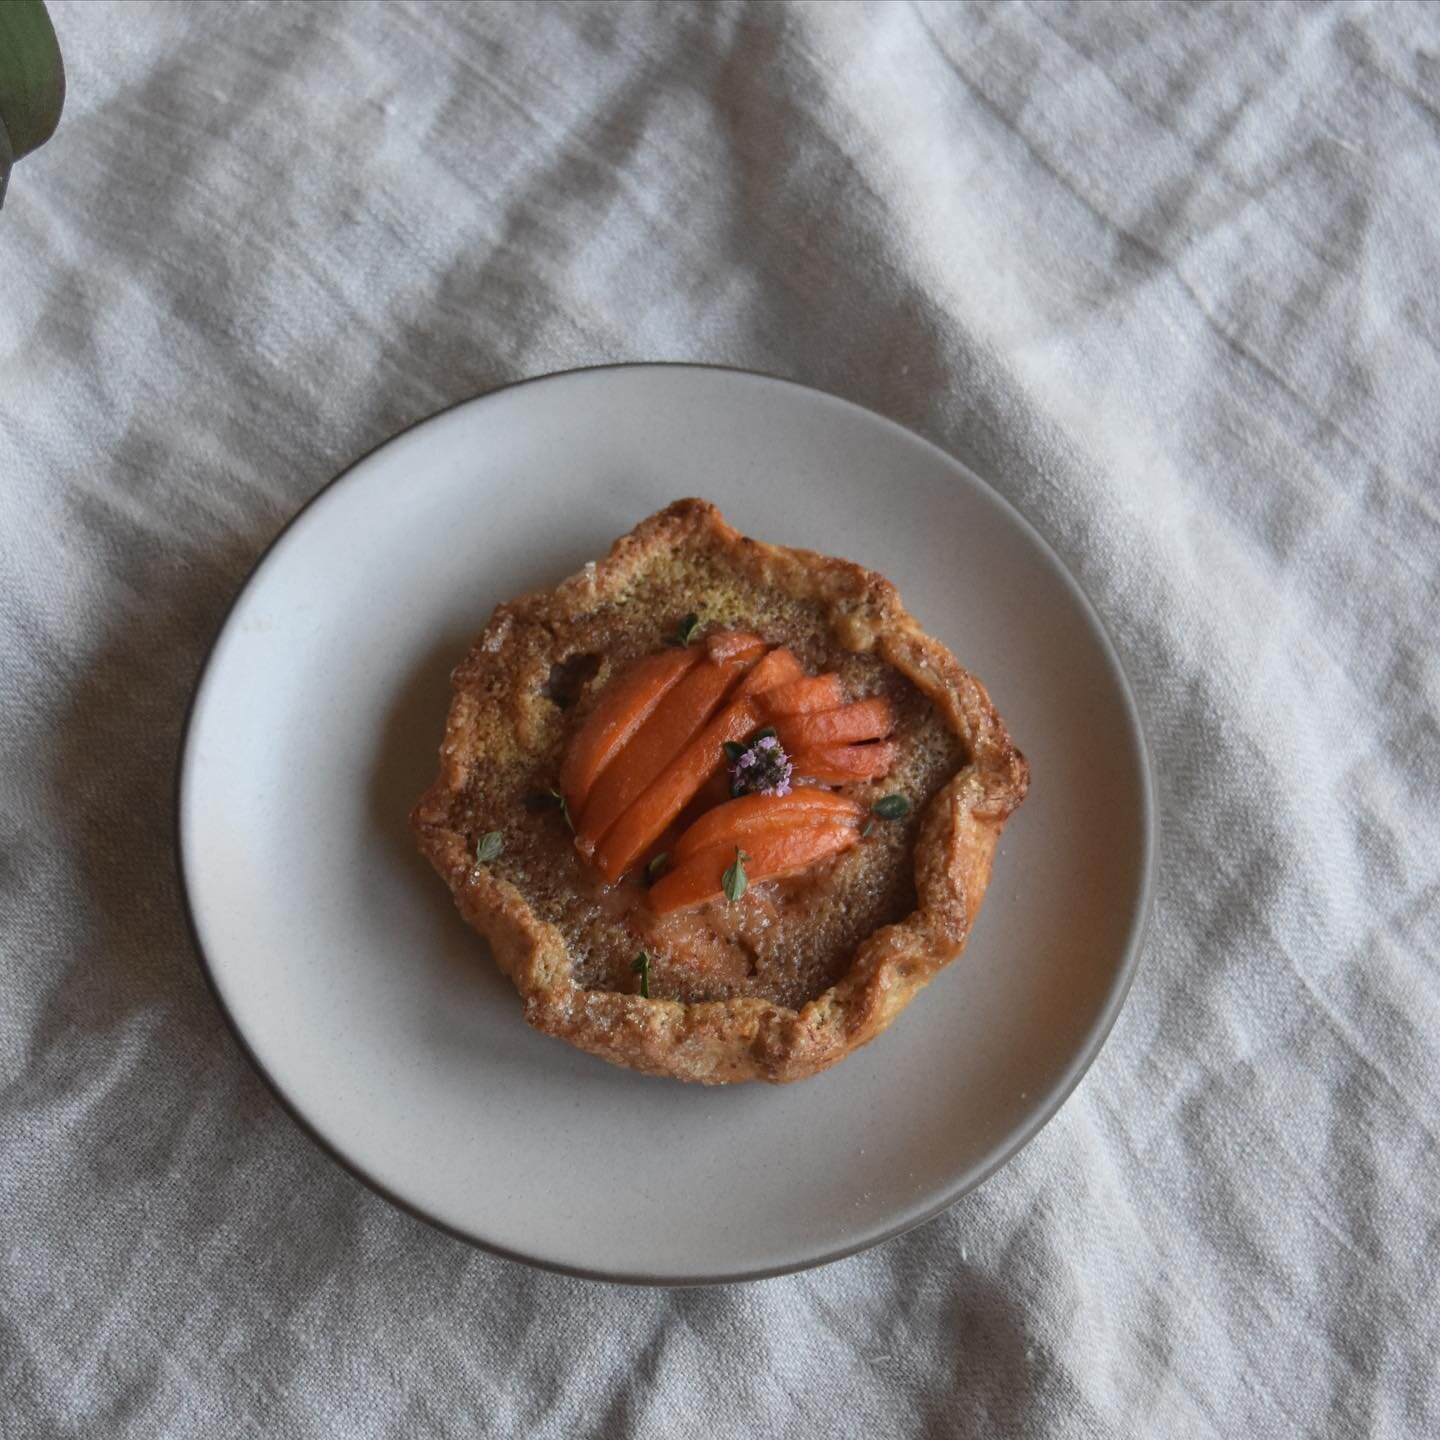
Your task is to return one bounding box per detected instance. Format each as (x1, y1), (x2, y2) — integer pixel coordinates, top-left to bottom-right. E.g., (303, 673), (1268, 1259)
(171, 360), (1159, 1289)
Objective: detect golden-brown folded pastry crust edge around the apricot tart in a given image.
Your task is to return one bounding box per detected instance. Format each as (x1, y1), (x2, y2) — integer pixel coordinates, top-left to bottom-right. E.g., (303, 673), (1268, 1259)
(410, 500), (1030, 1084)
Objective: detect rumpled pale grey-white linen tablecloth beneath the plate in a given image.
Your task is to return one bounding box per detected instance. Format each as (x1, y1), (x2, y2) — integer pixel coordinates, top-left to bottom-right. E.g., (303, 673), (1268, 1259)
(0, 0), (1440, 1440)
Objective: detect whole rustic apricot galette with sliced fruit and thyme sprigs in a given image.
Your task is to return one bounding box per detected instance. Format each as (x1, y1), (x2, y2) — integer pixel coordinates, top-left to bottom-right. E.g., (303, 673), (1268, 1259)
(412, 500), (1028, 1084)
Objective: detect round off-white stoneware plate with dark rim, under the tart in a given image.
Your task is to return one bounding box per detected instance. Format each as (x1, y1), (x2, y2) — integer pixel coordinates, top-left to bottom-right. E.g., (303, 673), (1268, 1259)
(179, 366), (1153, 1284)
